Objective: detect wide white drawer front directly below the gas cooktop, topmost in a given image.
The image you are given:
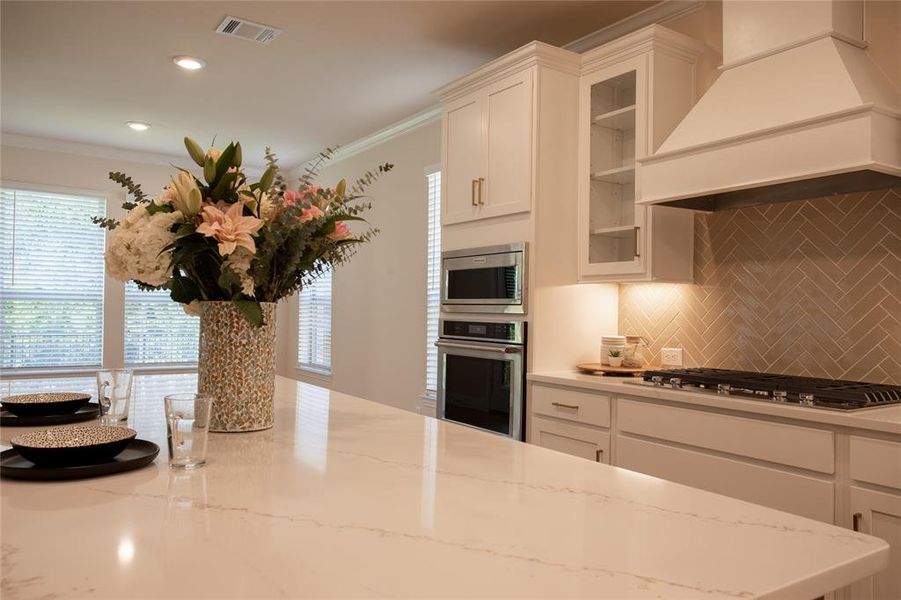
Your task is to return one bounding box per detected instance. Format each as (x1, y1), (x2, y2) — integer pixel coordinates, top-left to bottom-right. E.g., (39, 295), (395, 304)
(617, 399), (835, 473)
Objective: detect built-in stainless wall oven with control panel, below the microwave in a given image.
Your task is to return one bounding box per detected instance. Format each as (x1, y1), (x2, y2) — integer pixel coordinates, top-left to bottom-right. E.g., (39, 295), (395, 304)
(435, 318), (526, 440)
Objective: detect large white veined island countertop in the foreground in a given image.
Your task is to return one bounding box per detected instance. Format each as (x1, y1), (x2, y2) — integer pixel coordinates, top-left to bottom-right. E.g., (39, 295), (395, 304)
(0, 376), (888, 600)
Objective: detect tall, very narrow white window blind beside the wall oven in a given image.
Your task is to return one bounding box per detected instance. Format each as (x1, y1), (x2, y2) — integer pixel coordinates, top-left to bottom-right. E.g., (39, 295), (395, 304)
(425, 171), (441, 395)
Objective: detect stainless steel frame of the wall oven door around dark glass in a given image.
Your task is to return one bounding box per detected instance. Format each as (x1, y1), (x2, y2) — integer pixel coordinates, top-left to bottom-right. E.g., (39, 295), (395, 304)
(435, 340), (524, 440)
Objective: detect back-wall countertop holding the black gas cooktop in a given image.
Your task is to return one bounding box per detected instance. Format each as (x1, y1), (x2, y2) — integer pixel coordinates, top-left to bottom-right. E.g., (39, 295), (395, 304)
(528, 371), (901, 435)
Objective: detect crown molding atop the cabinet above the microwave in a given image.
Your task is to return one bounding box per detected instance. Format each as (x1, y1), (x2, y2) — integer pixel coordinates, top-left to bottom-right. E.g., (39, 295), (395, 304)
(433, 42), (581, 103)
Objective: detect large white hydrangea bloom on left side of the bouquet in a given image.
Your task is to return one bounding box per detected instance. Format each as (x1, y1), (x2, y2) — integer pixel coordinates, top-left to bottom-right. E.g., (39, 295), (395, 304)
(106, 205), (184, 285)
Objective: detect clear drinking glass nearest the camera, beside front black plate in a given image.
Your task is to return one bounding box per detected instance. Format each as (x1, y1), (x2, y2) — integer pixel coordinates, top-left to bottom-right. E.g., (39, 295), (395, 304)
(165, 394), (213, 469)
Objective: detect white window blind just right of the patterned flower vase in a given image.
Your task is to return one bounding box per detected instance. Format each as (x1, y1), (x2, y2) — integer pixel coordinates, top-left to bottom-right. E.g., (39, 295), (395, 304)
(297, 271), (332, 373)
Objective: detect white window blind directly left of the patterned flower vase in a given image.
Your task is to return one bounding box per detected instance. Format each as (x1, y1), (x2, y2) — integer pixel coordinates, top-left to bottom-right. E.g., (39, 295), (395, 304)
(125, 282), (200, 366)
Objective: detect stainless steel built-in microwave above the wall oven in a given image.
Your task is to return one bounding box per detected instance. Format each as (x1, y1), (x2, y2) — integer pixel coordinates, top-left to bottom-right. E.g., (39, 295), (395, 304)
(441, 242), (527, 315)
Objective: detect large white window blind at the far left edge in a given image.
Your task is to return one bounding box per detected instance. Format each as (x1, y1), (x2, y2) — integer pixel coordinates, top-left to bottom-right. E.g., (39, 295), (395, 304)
(0, 187), (106, 369)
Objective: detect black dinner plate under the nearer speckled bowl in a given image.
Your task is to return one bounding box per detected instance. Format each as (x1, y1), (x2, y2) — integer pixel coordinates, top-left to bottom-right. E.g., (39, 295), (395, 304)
(0, 440), (160, 481)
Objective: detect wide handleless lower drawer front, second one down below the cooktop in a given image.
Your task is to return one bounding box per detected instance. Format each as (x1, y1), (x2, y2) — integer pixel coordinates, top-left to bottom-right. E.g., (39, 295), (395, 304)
(616, 436), (834, 523)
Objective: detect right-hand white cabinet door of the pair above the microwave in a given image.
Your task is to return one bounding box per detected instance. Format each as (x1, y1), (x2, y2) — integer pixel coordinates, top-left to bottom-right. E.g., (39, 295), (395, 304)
(477, 69), (533, 218)
